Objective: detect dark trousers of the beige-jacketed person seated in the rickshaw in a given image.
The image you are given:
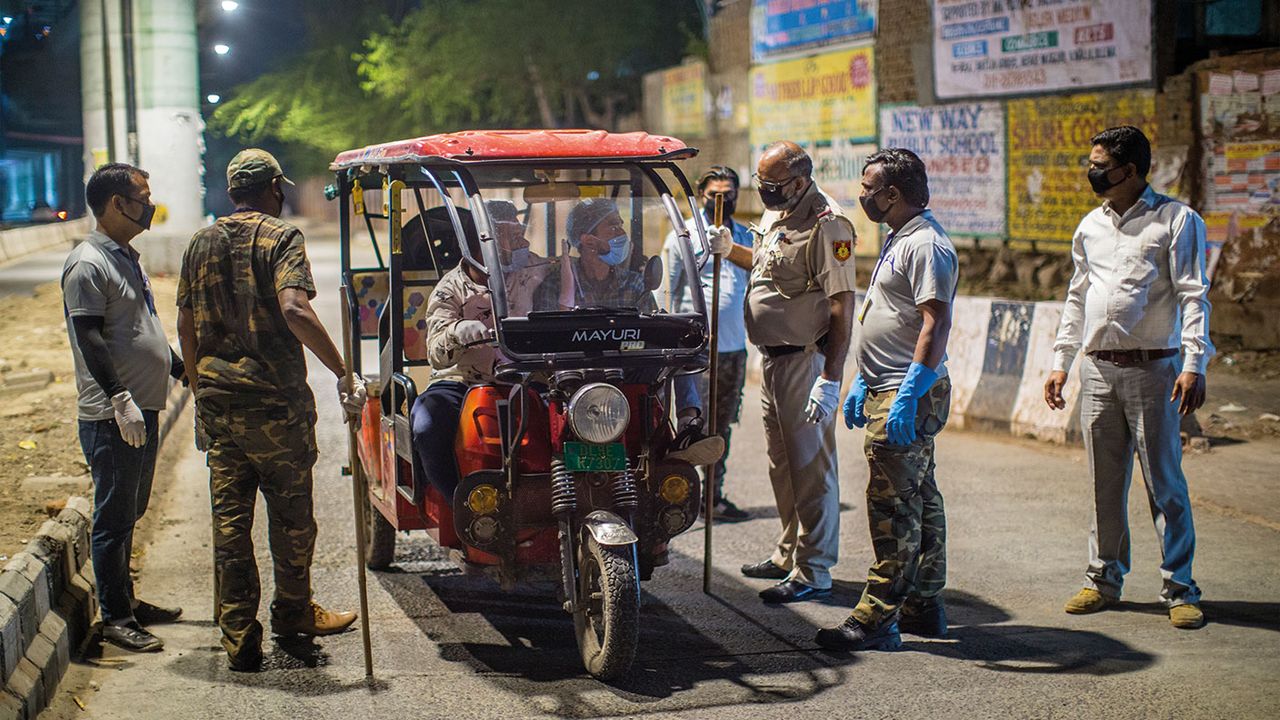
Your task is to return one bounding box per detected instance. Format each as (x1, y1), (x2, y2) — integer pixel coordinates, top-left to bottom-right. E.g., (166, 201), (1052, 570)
(410, 380), (467, 501)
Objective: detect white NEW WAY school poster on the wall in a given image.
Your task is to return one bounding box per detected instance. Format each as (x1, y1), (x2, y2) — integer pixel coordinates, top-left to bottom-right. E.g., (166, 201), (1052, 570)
(881, 102), (1005, 237)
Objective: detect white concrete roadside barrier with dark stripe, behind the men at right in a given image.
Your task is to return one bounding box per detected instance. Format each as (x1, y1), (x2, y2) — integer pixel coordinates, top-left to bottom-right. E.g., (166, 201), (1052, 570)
(748, 293), (1080, 443)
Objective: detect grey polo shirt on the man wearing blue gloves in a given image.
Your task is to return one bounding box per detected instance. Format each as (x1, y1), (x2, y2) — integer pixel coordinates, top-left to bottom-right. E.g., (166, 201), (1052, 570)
(858, 210), (959, 392)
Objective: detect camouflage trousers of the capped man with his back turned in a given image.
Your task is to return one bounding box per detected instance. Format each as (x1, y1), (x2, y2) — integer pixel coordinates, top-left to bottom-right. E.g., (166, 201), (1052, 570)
(196, 397), (316, 656)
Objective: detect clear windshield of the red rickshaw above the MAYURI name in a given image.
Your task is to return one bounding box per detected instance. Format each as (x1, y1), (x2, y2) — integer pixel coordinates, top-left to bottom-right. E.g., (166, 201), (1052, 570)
(468, 163), (703, 318)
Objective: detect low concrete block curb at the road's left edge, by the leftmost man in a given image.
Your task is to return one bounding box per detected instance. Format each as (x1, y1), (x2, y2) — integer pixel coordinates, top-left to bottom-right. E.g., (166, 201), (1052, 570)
(0, 383), (191, 720)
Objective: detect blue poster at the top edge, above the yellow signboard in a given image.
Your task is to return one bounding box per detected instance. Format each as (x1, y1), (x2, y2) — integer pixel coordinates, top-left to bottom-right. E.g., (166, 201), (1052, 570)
(751, 0), (877, 63)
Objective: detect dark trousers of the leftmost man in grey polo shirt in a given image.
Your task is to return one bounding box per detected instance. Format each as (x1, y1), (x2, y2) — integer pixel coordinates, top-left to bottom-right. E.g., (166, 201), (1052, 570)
(79, 410), (160, 624)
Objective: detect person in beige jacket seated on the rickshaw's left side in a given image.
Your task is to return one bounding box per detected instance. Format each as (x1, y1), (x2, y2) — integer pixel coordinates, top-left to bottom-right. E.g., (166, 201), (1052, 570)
(410, 200), (552, 498)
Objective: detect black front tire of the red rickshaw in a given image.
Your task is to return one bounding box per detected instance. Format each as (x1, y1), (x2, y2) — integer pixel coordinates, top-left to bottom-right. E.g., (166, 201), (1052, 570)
(573, 533), (640, 680)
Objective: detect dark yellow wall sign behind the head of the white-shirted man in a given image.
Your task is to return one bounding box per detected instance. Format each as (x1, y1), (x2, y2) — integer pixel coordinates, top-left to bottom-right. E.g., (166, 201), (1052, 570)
(1006, 90), (1158, 250)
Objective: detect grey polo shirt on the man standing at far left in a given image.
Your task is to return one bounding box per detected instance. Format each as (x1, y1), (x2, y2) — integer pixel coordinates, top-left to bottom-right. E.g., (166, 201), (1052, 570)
(63, 229), (170, 420)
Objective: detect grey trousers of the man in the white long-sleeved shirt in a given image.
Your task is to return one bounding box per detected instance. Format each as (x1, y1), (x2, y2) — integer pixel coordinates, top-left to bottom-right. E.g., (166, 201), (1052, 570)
(1080, 356), (1201, 606)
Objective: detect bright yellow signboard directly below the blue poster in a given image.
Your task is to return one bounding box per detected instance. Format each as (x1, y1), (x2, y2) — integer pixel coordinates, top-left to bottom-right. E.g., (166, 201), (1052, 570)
(750, 46), (876, 146)
